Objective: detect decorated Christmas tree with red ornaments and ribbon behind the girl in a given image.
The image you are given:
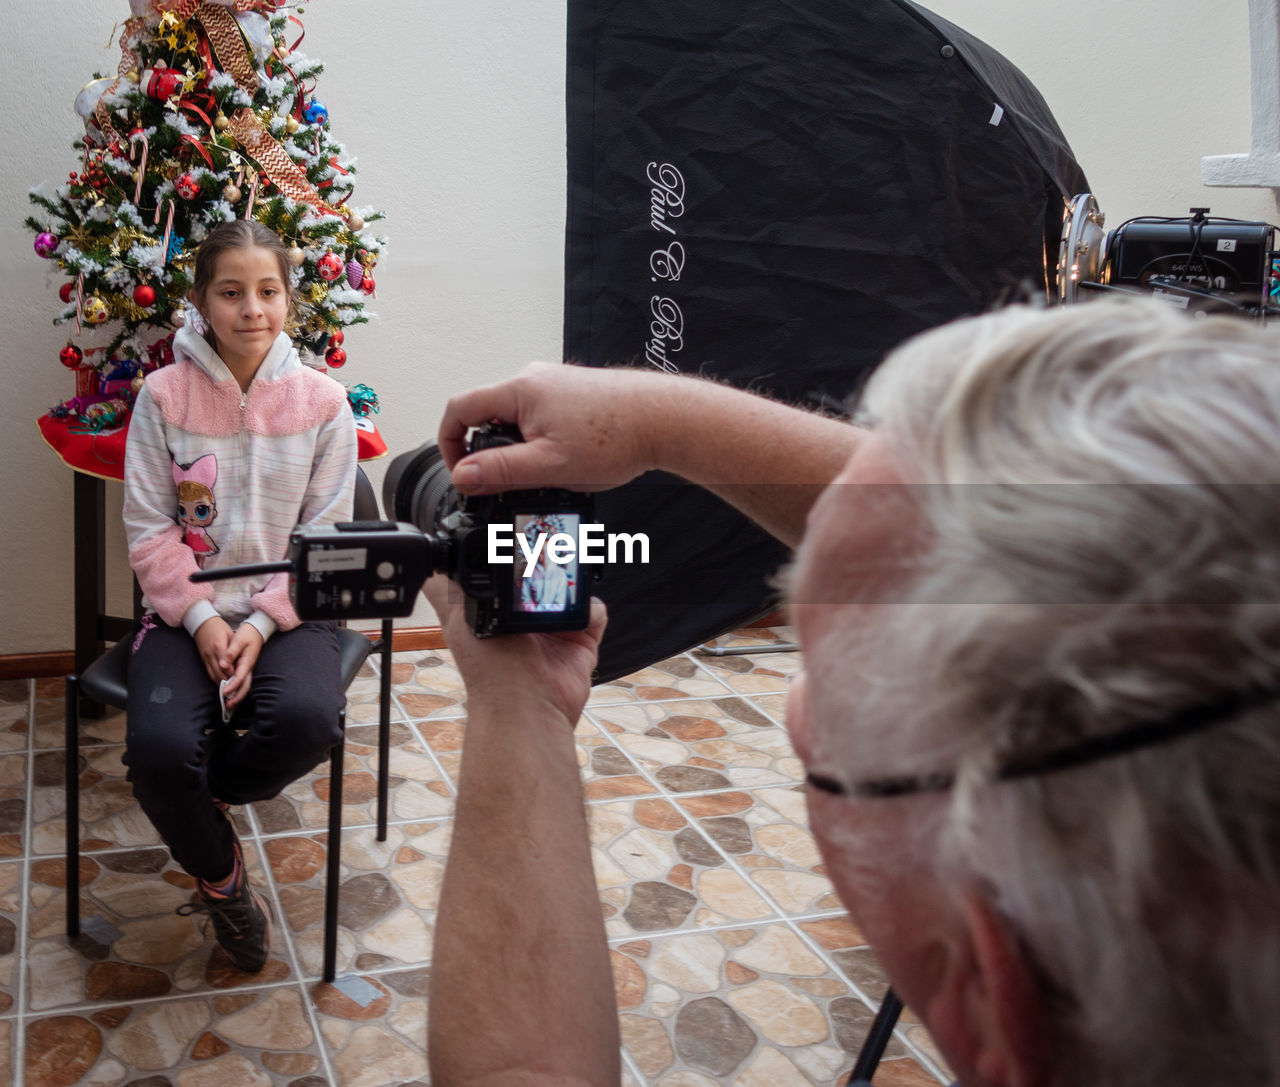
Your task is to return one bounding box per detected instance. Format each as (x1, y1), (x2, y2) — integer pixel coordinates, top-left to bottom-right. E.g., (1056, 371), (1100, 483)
(27, 0), (387, 458)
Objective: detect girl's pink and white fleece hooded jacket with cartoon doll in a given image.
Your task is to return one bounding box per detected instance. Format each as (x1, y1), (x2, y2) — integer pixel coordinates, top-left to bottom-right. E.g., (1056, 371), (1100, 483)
(124, 328), (356, 639)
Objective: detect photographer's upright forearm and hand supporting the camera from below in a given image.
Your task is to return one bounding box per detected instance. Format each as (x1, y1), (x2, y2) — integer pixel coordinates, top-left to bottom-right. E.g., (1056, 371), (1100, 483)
(426, 576), (621, 1087)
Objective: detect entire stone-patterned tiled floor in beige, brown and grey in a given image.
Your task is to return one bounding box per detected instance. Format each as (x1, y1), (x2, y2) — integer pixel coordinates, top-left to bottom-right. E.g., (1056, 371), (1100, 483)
(0, 629), (940, 1087)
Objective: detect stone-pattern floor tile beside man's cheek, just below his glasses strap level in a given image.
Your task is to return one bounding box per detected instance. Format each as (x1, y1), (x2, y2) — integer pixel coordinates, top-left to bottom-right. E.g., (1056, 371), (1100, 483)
(675, 785), (844, 917)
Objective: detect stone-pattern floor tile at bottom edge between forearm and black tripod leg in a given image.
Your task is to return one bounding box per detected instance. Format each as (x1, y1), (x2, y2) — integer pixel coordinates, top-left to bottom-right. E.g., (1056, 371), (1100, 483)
(611, 922), (921, 1087)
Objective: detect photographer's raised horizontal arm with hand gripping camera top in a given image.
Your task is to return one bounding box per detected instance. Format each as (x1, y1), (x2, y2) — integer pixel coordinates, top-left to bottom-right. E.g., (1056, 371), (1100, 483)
(439, 362), (861, 545)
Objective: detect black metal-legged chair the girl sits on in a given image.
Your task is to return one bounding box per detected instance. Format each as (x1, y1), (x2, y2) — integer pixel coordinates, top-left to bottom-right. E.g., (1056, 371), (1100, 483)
(65, 471), (392, 982)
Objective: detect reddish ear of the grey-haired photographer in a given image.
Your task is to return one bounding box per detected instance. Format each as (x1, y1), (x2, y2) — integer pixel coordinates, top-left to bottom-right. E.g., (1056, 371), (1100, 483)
(925, 894), (1051, 1087)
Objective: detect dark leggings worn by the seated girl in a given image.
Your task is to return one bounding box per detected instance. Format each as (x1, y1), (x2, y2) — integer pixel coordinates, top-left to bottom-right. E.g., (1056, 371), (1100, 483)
(124, 615), (346, 881)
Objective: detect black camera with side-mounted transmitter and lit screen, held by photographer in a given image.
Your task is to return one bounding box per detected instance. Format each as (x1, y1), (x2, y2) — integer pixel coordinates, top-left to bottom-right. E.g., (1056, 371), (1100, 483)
(192, 424), (603, 638)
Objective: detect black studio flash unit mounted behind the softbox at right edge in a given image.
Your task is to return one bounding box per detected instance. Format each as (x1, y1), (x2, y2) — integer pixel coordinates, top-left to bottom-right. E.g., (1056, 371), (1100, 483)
(1059, 192), (1280, 320)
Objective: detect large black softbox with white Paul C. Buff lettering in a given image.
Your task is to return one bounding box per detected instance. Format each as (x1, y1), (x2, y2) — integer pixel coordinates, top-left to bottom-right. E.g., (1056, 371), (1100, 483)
(564, 0), (1088, 679)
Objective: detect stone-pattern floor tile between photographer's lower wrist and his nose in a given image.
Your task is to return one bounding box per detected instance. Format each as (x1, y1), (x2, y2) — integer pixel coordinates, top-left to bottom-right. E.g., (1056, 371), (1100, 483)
(588, 698), (804, 793)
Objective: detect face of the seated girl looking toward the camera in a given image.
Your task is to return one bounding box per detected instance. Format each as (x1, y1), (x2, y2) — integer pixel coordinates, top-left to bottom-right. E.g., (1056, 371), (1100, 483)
(196, 246), (289, 376)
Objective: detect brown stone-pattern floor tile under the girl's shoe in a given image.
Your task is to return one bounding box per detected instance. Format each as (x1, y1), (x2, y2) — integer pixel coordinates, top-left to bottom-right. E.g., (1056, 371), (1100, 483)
(26, 841), (293, 1013)
